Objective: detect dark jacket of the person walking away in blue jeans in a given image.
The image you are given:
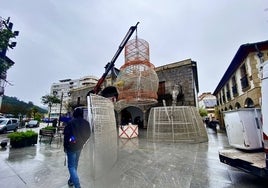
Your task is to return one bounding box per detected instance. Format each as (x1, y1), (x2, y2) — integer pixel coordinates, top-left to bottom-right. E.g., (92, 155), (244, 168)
(63, 117), (91, 151)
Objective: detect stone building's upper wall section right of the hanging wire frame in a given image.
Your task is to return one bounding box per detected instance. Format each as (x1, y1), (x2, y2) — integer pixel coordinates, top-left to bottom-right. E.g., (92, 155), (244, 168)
(155, 59), (199, 106)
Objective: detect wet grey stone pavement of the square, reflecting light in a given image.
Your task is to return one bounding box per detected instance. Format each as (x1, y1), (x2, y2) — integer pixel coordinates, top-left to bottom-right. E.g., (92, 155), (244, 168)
(0, 124), (268, 188)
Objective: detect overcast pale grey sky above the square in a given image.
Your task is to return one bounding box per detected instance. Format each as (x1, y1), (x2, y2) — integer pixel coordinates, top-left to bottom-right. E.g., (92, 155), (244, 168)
(0, 0), (268, 106)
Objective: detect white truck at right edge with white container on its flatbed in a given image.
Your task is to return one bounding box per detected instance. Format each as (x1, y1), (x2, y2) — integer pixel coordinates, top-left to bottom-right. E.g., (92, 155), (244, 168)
(219, 61), (268, 177)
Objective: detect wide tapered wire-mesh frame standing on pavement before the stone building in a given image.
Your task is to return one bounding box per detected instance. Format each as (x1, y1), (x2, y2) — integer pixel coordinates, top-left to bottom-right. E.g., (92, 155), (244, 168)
(147, 106), (208, 143)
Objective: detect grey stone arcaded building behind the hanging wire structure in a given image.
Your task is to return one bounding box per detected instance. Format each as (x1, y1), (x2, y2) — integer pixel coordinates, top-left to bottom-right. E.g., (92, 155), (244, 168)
(67, 59), (199, 128)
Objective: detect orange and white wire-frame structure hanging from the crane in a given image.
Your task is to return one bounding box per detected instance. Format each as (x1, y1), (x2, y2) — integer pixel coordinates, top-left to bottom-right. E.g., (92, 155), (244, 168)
(115, 37), (158, 105)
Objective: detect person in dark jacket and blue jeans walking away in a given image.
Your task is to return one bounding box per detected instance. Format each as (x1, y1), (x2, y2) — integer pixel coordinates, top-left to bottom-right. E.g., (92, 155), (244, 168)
(63, 108), (91, 188)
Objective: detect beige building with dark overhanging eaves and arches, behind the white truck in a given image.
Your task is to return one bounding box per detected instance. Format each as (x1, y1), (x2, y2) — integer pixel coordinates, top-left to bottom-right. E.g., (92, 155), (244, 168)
(213, 41), (268, 127)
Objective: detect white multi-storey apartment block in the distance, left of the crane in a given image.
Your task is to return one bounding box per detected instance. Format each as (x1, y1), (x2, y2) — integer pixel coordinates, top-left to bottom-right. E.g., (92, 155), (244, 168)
(50, 76), (98, 118)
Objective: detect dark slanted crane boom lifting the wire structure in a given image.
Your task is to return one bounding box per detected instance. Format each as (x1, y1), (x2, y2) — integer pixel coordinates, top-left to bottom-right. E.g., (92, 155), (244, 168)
(91, 22), (139, 94)
